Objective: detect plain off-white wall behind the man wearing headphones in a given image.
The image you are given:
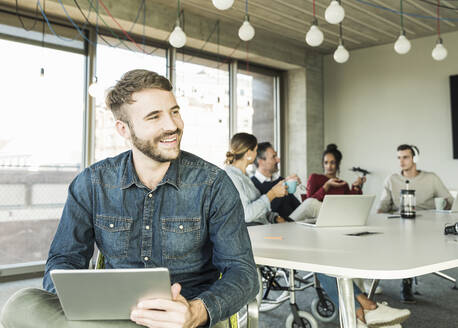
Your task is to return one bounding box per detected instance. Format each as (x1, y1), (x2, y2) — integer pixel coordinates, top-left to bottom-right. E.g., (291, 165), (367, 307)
(324, 32), (458, 210)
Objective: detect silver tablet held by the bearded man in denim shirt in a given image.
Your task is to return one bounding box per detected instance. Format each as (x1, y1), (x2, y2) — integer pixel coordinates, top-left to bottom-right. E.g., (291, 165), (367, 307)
(51, 268), (171, 320)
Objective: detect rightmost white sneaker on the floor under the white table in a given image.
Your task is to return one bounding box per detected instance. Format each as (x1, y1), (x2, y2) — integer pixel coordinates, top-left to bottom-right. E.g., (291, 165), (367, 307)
(364, 302), (410, 328)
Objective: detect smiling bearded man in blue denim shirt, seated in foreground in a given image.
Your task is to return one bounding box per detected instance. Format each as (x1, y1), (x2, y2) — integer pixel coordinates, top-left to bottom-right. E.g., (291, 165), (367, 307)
(2, 70), (259, 328)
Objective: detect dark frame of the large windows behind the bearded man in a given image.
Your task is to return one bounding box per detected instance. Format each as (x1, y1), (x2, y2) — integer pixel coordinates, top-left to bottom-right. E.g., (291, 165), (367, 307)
(0, 10), (284, 282)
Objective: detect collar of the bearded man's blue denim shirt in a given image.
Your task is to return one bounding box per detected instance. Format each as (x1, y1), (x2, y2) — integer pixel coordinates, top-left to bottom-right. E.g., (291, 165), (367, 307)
(121, 150), (181, 189)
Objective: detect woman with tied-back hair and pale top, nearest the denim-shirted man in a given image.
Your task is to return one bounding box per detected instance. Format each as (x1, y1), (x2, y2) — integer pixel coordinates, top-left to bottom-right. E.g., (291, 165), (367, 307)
(224, 133), (288, 225)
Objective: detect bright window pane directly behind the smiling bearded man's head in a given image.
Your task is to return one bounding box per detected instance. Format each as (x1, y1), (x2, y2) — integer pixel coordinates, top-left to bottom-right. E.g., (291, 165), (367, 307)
(95, 40), (166, 161)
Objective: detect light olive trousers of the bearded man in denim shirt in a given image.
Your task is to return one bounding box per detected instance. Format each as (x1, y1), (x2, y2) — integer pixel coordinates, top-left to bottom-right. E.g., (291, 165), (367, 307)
(1, 288), (229, 328)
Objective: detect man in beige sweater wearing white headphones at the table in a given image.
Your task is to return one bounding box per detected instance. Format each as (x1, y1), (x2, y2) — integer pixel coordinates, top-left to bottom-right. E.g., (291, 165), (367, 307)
(377, 144), (453, 303)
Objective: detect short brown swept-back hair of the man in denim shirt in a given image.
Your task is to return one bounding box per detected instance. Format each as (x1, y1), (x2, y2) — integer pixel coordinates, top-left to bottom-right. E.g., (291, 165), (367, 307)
(105, 69), (172, 123)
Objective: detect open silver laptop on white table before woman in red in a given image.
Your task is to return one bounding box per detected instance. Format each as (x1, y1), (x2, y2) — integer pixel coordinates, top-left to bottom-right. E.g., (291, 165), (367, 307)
(296, 195), (375, 227)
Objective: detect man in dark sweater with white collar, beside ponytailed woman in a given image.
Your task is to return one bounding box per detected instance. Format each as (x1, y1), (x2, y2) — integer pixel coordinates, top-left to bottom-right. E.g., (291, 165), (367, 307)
(251, 142), (301, 218)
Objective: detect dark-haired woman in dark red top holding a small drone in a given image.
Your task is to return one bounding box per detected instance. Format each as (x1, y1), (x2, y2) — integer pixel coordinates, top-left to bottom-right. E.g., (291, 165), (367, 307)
(291, 144), (366, 220)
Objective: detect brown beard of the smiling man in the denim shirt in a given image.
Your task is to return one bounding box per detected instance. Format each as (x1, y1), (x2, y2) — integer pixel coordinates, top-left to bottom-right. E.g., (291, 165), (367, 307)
(129, 127), (183, 163)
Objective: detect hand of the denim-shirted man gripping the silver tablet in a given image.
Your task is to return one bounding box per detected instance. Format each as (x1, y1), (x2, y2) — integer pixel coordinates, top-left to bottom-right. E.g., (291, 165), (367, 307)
(130, 283), (208, 328)
